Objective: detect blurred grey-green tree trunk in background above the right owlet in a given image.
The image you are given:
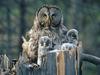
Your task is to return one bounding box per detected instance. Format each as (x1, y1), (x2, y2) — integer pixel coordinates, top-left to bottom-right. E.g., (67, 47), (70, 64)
(70, 0), (82, 30)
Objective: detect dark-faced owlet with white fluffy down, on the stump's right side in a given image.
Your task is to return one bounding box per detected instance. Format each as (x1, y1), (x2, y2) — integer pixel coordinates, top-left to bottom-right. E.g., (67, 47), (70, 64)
(61, 29), (79, 50)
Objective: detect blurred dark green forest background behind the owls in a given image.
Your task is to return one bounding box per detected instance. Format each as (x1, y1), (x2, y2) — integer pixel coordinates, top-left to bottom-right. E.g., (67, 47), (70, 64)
(0, 0), (100, 75)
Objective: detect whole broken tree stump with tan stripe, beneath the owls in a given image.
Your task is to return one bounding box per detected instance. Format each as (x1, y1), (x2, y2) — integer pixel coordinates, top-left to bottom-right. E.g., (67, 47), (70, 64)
(17, 43), (80, 75)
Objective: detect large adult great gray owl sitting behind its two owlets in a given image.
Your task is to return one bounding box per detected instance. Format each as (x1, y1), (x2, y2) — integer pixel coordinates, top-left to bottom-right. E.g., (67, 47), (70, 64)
(21, 5), (67, 63)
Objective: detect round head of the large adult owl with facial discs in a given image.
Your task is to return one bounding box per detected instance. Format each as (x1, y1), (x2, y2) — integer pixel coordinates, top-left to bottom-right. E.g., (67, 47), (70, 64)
(34, 5), (63, 29)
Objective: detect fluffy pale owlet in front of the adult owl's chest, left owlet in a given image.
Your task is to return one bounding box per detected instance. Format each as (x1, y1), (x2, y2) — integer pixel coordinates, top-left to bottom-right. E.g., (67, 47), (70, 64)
(37, 36), (52, 67)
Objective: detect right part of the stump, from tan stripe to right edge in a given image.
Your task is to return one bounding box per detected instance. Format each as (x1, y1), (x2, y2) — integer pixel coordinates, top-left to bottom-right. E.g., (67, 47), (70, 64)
(56, 44), (79, 75)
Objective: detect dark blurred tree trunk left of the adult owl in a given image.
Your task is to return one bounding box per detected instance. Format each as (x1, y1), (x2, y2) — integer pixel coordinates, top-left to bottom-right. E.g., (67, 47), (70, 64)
(19, 0), (26, 53)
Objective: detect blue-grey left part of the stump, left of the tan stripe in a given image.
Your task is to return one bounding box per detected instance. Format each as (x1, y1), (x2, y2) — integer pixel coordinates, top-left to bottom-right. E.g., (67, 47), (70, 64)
(17, 53), (57, 75)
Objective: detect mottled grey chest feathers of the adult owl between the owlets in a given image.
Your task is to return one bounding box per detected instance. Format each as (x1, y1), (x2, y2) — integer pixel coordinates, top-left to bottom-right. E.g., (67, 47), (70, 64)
(40, 29), (67, 44)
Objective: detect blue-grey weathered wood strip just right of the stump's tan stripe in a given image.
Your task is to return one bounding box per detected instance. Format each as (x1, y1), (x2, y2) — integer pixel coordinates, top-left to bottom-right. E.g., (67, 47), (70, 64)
(64, 49), (76, 75)
